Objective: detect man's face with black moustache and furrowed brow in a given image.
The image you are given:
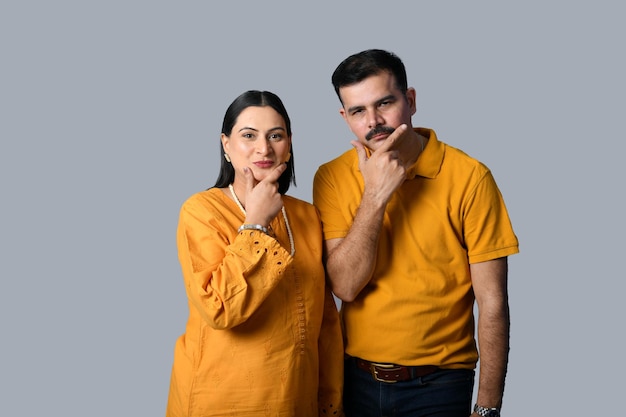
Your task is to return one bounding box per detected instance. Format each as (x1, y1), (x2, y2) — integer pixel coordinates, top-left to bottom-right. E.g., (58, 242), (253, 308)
(339, 71), (415, 151)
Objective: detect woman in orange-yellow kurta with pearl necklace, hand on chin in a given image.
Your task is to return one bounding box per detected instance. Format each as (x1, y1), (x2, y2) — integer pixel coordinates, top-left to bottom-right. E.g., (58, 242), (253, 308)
(166, 91), (343, 417)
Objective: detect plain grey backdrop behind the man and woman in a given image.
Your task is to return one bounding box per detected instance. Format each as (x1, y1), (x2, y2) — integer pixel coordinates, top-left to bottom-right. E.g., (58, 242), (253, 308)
(0, 1), (626, 416)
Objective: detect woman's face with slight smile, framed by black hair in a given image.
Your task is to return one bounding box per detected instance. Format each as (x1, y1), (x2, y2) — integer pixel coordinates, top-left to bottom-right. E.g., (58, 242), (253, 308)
(222, 106), (291, 184)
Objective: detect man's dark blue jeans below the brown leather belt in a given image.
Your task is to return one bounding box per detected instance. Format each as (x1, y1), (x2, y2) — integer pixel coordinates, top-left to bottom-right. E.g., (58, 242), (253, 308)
(343, 359), (474, 417)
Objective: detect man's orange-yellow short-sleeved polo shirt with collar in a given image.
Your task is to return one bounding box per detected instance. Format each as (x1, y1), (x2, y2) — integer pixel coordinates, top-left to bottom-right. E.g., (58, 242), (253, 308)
(313, 128), (518, 369)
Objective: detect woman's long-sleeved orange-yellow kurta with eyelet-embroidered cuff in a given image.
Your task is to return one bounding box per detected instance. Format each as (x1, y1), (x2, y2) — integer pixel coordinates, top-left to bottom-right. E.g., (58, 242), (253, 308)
(166, 188), (343, 417)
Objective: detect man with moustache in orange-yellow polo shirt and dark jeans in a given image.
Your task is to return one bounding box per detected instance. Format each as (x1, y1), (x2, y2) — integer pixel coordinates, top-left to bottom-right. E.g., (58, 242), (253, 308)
(313, 50), (518, 417)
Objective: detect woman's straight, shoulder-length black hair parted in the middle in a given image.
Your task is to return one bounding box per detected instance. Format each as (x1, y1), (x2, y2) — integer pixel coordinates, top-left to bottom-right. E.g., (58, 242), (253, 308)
(213, 90), (296, 194)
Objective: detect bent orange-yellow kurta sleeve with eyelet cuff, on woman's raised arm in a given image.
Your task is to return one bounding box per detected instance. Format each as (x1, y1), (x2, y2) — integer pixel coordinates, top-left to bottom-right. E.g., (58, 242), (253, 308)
(177, 192), (292, 329)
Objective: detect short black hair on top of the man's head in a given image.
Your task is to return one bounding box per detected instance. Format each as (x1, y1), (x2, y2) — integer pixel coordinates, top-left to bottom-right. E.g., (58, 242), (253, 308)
(332, 49), (408, 104)
